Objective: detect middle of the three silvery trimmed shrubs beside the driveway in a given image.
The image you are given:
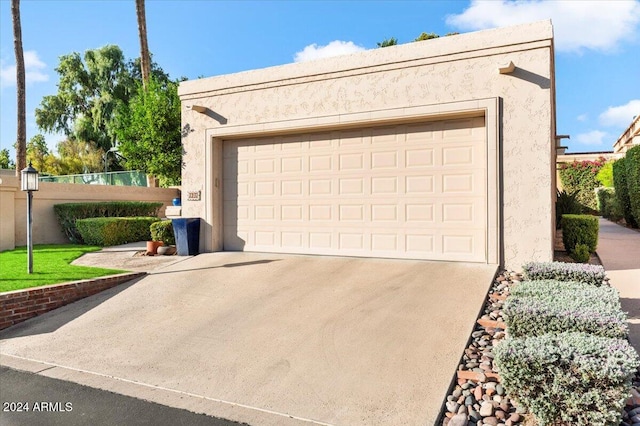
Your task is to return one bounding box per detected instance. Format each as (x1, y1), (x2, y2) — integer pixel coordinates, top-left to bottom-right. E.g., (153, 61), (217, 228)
(503, 281), (629, 339)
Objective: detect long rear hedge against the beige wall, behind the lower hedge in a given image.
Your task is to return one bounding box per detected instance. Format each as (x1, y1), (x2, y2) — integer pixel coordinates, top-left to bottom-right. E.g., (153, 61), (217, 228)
(53, 201), (162, 244)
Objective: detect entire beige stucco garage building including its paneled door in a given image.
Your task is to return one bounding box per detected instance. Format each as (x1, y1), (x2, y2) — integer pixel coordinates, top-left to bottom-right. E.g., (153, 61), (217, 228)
(179, 21), (556, 269)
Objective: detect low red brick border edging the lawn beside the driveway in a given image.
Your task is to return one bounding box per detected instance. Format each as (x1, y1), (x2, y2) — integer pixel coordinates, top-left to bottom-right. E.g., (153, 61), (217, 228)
(0, 272), (147, 330)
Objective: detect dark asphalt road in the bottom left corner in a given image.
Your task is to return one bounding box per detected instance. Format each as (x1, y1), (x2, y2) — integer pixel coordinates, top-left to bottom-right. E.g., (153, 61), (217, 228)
(0, 367), (246, 426)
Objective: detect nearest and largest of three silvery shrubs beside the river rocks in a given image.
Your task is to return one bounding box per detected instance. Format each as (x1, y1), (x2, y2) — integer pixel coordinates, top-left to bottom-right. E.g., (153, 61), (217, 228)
(494, 333), (640, 425)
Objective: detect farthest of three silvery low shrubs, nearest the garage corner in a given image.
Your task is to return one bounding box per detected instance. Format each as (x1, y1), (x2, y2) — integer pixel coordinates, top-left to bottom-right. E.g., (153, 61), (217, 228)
(522, 262), (606, 286)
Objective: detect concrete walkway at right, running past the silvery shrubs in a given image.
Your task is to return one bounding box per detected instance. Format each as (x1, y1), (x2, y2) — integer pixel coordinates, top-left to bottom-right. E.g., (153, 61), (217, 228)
(597, 218), (640, 352)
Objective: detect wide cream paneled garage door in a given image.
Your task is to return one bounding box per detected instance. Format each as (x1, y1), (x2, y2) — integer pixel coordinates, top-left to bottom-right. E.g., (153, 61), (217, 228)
(223, 118), (487, 262)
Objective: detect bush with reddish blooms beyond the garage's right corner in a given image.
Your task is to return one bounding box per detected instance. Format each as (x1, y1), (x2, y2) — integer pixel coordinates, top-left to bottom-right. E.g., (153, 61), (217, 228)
(559, 157), (606, 213)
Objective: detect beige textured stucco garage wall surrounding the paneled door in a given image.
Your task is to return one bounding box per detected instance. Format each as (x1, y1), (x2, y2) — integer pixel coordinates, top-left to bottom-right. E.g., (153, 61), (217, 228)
(179, 21), (555, 269)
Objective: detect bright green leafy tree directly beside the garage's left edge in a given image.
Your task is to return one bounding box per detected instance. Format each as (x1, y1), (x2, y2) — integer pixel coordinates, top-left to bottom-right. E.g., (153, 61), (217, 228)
(116, 76), (182, 185)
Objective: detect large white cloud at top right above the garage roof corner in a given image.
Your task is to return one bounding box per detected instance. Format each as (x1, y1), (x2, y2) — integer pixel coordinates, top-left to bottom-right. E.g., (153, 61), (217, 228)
(446, 0), (640, 51)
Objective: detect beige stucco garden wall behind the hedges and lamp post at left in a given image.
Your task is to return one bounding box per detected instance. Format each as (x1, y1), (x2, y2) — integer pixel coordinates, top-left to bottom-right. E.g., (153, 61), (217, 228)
(0, 176), (178, 251)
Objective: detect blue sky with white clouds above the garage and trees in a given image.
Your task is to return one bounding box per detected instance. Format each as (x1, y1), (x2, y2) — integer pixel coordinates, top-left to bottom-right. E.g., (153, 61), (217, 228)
(0, 0), (640, 160)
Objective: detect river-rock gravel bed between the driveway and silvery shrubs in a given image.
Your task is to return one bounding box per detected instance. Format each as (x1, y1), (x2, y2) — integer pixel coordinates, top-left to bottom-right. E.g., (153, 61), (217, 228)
(441, 271), (640, 426)
